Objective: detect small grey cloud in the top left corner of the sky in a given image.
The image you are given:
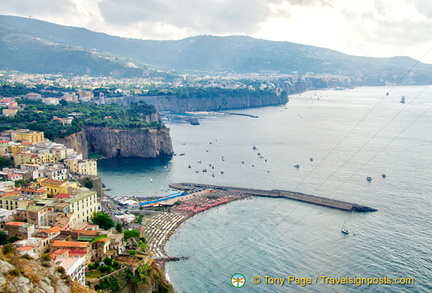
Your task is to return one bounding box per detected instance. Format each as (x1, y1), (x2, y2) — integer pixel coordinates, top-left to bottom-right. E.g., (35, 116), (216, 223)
(1, 0), (76, 17)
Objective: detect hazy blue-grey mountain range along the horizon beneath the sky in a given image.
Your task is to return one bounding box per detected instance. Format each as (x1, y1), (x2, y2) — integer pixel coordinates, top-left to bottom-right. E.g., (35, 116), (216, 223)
(0, 16), (432, 85)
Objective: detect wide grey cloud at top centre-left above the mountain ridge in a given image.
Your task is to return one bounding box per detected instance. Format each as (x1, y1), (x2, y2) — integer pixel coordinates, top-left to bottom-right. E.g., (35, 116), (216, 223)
(99, 0), (275, 34)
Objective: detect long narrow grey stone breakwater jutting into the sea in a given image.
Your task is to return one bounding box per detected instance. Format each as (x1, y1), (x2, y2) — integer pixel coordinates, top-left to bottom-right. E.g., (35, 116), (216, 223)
(170, 182), (377, 213)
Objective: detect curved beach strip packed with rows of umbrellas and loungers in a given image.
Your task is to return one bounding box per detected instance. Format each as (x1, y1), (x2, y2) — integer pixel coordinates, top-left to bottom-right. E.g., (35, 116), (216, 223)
(142, 189), (251, 270)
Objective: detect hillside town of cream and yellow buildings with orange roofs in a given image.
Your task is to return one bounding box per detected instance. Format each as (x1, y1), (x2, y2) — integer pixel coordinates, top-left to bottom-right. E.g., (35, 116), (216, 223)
(0, 129), (155, 285)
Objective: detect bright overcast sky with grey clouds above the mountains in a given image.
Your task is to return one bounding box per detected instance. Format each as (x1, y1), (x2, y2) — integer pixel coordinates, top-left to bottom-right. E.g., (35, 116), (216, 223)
(0, 0), (432, 64)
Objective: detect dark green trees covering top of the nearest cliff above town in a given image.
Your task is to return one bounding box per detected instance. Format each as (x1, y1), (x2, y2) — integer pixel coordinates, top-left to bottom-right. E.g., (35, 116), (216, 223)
(0, 99), (163, 140)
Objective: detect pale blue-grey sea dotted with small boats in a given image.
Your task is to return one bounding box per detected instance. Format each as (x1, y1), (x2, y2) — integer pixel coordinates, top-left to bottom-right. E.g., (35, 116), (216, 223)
(98, 86), (432, 292)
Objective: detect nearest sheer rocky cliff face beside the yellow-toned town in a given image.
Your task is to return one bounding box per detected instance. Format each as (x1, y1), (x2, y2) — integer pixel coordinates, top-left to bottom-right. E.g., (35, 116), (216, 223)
(65, 126), (174, 158)
